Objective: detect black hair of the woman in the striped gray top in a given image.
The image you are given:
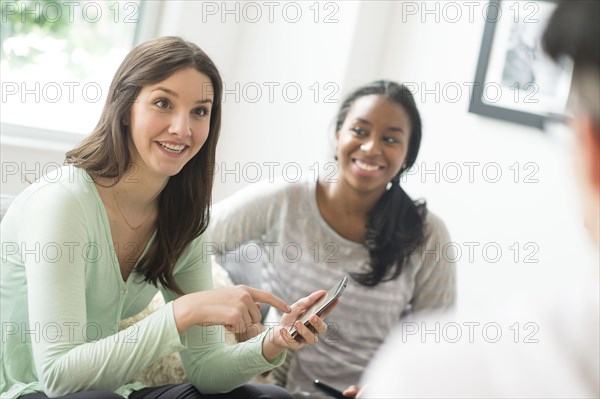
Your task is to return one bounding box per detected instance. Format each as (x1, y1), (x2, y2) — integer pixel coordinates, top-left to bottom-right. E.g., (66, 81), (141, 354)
(335, 80), (427, 286)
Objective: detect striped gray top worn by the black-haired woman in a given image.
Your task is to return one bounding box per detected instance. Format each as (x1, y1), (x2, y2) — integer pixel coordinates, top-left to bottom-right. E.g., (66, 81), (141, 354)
(207, 180), (456, 396)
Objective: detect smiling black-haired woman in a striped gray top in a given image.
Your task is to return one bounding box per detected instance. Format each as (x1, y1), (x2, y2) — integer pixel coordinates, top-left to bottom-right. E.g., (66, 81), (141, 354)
(209, 81), (455, 396)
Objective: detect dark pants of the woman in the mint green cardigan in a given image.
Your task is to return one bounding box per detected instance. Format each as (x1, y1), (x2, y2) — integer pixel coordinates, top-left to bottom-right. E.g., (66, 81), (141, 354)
(21, 383), (292, 399)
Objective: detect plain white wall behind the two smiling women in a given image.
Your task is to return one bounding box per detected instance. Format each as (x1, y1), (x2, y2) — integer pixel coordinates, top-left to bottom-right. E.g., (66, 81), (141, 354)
(2, 1), (589, 310)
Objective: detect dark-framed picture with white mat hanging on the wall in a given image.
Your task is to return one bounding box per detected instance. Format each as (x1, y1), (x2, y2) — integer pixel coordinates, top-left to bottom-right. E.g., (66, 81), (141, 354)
(469, 0), (573, 129)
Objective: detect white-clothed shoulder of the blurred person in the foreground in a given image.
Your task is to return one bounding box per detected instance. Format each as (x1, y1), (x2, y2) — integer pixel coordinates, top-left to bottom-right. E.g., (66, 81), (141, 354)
(361, 269), (600, 398)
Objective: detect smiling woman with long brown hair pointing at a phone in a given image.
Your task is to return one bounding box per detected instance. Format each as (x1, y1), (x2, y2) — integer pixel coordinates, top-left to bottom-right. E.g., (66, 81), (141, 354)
(0, 37), (324, 399)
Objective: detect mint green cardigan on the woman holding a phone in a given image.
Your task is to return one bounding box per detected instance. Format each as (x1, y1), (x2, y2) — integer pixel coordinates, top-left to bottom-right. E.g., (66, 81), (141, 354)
(0, 166), (285, 398)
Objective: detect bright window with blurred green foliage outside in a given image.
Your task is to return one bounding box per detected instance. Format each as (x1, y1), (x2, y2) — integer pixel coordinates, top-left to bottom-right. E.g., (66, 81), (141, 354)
(0, 0), (158, 141)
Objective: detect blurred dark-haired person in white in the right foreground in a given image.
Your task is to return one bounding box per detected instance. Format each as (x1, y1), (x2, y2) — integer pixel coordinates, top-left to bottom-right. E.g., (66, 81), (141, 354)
(359, 1), (600, 398)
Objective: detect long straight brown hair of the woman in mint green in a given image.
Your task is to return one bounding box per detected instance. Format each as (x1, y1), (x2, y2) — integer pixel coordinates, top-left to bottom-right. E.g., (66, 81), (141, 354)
(65, 36), (223, 294)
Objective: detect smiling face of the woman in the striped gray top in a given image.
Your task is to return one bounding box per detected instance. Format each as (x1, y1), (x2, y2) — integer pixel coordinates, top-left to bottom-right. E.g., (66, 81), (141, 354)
(336, 95), (411, 193)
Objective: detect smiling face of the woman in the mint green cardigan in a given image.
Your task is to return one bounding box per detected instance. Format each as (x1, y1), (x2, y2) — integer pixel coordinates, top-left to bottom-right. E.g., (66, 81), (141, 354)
(129, 68), (213, 183)
